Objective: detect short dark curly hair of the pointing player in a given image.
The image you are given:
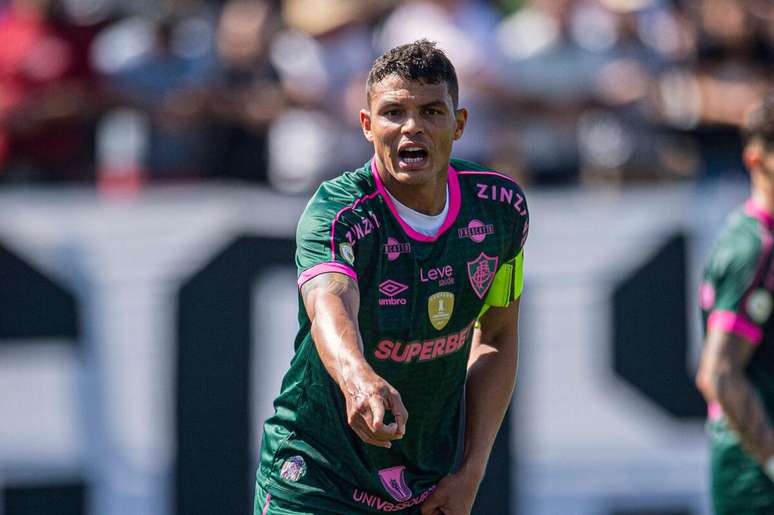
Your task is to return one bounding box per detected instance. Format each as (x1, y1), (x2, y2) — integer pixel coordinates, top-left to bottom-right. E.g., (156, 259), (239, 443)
(366, 39), (459, 109)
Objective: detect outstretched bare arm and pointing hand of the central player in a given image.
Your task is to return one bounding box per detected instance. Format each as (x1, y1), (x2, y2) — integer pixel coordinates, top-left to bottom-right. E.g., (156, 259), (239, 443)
(301, 272), (408, 448)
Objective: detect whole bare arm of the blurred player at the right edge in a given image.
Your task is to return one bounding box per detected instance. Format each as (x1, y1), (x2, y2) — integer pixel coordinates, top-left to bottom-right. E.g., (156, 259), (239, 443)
(696, 329), (774, 465)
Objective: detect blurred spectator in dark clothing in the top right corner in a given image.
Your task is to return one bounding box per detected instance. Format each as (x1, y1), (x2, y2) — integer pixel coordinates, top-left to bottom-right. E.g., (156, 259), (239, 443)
(654, 0), (774, 175)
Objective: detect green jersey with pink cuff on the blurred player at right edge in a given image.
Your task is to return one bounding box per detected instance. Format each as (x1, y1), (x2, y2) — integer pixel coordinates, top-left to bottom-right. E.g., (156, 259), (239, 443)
(699, 200), (774, 513)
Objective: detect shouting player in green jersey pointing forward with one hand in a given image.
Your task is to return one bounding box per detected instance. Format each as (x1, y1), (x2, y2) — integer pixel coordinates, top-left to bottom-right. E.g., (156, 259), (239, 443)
(255, 40), (527, 515)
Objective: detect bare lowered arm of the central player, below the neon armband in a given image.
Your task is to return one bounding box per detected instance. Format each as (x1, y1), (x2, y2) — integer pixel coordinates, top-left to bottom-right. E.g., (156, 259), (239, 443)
(461, 331), (518, 481)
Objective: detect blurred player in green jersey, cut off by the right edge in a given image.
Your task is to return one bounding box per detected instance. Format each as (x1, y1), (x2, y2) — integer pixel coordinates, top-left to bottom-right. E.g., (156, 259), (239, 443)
(696, 94), (774, 515)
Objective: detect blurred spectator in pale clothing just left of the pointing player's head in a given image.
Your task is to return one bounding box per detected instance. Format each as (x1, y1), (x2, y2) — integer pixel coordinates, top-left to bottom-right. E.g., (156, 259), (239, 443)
(270, 0), (390, 192)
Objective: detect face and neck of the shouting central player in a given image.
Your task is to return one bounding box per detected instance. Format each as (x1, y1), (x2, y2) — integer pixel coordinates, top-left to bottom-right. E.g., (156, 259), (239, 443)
(360, 75), (468, 215)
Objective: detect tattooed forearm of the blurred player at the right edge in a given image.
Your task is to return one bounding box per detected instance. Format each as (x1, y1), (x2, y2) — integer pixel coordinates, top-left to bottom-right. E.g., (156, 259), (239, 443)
(712, 371), (774, 465)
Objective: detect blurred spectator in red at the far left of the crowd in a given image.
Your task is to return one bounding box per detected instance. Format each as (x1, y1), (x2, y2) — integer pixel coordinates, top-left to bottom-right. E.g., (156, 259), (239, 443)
(0, 0), (103, 181)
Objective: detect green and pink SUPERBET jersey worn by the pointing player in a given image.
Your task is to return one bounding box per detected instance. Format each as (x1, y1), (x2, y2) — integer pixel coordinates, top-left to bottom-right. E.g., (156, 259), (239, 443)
(258, 159), (528, 513)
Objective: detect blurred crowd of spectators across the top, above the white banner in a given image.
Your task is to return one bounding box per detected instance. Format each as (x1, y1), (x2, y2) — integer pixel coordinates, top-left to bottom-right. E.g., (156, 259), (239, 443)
(0, 0), (774, 193)
